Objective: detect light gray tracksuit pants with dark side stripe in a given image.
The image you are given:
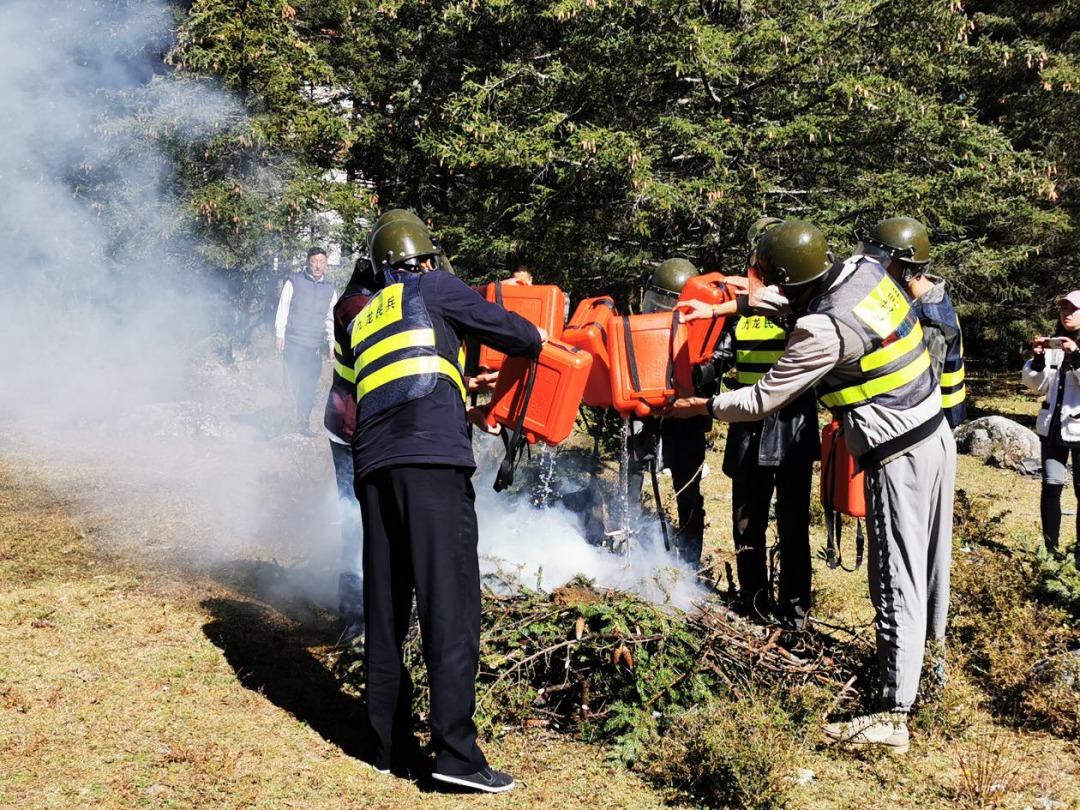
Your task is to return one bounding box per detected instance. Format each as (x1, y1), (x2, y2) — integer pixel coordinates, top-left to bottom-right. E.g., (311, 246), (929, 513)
(866, 421), (956, 712)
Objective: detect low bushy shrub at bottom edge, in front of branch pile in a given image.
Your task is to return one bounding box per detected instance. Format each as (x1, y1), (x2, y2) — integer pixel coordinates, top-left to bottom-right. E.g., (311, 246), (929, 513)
(638, 697), (795, 810)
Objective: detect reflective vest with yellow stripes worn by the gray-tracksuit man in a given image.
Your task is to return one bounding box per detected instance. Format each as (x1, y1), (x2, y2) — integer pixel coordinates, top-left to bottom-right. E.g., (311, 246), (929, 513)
(807, 258), (937, 413)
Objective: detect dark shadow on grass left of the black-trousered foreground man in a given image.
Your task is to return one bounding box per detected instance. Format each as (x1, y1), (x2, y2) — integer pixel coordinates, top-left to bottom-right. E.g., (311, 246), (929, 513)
(202, 598), (368, 758)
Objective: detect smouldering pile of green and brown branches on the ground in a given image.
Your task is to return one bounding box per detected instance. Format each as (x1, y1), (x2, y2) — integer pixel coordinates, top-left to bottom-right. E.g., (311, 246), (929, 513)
(334, 580), (859, 741)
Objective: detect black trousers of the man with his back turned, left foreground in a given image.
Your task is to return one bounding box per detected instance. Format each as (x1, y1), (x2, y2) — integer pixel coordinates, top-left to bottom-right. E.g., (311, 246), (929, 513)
(356, 467), (487, 775)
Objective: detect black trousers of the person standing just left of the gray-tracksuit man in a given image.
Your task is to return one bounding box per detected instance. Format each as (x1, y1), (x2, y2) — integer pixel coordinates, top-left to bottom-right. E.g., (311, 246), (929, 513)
(731, 460), (813, 621)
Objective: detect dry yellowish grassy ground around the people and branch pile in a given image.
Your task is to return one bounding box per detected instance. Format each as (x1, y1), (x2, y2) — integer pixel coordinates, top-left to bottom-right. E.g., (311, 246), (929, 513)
(0, 384), (1080, 810)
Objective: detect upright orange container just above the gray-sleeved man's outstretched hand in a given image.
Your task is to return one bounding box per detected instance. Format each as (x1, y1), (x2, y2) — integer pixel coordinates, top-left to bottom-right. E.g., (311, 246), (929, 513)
(607, 311), (693, 416)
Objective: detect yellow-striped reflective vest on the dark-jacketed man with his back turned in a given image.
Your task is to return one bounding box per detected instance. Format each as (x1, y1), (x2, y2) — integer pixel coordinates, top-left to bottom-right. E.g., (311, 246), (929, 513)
(350, 270), (465, 422)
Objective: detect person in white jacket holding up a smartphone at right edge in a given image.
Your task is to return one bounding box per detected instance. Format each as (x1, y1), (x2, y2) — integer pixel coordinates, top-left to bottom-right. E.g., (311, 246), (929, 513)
(1022, 289), (1080, 565)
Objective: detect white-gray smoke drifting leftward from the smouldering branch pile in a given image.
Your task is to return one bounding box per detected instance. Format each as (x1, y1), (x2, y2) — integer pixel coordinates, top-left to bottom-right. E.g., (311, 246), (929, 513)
(0, 0), (698, 622)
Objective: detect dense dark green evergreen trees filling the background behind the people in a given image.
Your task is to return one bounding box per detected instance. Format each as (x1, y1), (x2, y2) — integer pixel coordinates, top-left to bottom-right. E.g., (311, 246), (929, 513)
(164, 0), (1080, 357)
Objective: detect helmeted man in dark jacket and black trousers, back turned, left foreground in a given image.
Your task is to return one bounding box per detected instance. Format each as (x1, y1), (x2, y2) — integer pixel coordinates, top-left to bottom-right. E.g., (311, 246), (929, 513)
(350, 213), (545, 793)
